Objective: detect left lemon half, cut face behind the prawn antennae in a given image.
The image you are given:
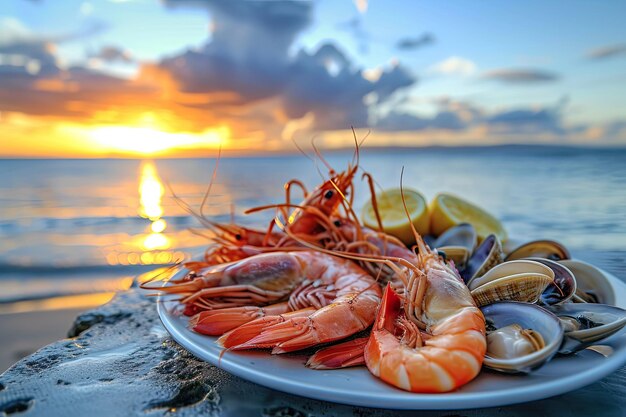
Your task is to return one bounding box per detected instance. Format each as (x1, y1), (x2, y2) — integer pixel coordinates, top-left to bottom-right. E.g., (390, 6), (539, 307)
(361, 188), (430, 245)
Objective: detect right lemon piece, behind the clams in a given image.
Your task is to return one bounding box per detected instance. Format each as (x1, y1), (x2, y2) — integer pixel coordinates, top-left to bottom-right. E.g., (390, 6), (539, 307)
(430, 193), (507, 242)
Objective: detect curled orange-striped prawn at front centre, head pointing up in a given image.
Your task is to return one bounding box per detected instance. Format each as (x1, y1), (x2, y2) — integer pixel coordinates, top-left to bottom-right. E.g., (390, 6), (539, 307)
(365, 233), (487, 392)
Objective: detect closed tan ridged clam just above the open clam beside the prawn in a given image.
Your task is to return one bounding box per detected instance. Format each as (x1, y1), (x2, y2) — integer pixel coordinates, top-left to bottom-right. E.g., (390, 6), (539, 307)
(467, 260), (554, 306)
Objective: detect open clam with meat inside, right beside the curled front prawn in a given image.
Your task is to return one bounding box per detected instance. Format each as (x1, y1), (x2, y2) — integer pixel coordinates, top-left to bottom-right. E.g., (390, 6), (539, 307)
(481, 301), (563, 373)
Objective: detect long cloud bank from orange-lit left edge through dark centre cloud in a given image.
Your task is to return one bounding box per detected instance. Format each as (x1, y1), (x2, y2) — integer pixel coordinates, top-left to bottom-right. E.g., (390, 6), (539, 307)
(0, 0), (415, 147)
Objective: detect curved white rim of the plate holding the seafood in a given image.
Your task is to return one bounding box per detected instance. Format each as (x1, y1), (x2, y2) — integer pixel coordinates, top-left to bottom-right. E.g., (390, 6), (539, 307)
(157, 259), (626, 410)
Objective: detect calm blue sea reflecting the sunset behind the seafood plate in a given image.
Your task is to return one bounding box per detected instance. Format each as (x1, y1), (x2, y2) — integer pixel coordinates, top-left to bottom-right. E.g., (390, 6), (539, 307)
(0, 146), (626, 312)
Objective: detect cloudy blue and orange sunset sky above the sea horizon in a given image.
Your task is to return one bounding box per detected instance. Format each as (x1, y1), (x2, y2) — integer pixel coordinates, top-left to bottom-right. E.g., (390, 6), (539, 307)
(0, 0), (626, 157)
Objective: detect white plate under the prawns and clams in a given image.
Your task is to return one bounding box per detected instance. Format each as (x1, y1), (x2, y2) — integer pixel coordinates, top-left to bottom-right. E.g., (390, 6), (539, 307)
(157, 262), (626, 410)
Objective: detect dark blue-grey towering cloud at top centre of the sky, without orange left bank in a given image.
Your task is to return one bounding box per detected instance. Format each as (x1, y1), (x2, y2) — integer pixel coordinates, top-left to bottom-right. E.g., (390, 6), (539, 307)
(160, 0), (415, 129)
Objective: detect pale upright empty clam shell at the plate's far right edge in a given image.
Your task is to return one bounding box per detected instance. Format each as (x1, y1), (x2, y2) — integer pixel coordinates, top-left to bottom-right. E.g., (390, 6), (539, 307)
(559, 259), (615, 305)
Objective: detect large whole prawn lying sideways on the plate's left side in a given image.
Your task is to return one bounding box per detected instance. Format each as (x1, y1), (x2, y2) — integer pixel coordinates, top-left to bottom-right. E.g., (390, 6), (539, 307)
(151, 251), (381, 344)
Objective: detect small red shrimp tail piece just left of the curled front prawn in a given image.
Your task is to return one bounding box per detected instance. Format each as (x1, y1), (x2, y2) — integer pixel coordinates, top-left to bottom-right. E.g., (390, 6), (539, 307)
(306, 336), (369, 369)
